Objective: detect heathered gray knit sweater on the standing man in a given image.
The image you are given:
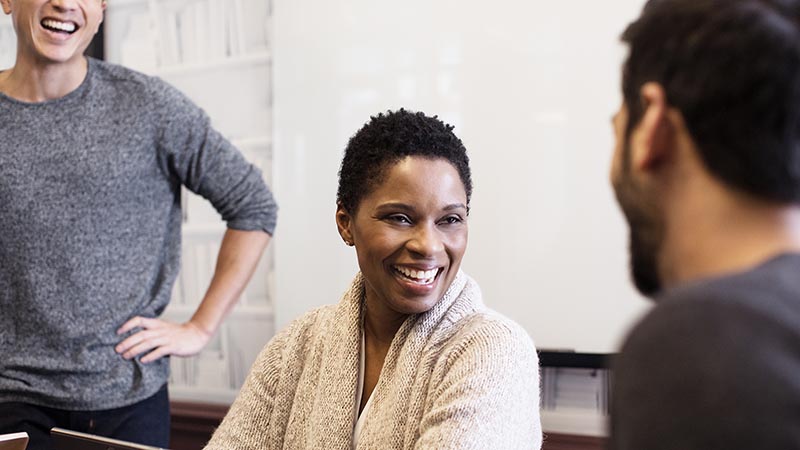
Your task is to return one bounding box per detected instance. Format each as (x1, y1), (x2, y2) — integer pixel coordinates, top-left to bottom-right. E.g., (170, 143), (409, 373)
(0, 59), (276, 410)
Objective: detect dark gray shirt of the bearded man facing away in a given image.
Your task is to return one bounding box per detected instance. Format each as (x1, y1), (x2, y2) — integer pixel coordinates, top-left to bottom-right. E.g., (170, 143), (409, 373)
(611, 254), (800, 450)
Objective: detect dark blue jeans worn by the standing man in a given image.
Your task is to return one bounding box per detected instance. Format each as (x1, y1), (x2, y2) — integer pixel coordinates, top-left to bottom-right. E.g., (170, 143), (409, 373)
(0, 385), (169, 450)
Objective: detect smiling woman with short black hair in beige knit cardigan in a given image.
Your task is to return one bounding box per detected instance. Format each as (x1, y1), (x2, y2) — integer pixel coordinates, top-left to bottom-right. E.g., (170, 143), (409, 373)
(207, 109), (541, 449)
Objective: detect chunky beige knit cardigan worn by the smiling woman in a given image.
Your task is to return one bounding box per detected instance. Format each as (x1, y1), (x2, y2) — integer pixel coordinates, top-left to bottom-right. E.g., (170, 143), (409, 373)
(206, 273), (542, 450)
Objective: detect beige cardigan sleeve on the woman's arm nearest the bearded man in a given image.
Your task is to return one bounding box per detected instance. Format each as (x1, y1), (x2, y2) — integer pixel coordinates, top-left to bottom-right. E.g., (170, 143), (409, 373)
(415, 316), (542, 450)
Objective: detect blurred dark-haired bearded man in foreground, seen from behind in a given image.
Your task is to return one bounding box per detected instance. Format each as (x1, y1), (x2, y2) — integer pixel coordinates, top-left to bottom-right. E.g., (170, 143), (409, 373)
(610, 0), (800, 450)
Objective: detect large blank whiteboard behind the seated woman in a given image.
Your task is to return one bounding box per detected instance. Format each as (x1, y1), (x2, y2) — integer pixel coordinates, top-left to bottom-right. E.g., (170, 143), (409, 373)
(273, 0), (648, 352)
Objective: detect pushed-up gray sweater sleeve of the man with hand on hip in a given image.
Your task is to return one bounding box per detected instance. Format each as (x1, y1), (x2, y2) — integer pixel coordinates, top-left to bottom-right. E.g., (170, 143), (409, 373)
(152, 79), (277, 234)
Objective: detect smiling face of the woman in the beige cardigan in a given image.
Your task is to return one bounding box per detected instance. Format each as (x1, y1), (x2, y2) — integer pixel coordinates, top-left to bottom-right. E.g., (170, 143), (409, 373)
(336, 156), (467, 315)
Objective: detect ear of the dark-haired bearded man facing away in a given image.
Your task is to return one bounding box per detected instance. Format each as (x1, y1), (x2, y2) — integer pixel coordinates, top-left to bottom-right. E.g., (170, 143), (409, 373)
(631, 82), (675, 170)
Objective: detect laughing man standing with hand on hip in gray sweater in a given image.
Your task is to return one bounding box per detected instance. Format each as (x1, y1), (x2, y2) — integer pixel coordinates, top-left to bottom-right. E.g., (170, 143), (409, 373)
(0, 0), (277, 449)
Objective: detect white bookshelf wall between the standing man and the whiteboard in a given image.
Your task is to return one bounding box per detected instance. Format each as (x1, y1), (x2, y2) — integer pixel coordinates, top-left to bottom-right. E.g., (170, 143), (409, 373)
(104, 0), (274, 405)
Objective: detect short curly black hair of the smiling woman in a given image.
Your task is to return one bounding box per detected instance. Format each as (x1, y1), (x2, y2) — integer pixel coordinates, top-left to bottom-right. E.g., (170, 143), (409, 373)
(336, 108), (472, 214)
